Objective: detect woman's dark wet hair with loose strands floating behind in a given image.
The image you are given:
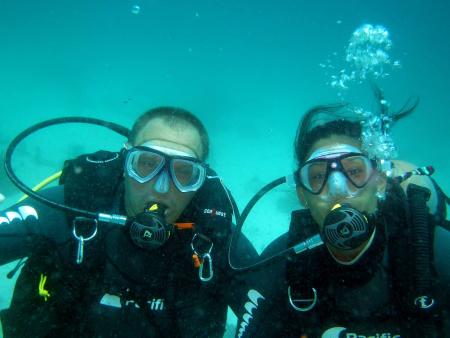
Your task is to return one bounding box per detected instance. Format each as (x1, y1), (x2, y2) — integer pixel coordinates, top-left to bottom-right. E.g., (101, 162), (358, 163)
(294, 86), (419, 167)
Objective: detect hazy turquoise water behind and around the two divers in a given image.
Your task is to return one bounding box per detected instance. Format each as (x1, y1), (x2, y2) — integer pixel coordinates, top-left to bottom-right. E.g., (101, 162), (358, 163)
(0, 0), (450, 335)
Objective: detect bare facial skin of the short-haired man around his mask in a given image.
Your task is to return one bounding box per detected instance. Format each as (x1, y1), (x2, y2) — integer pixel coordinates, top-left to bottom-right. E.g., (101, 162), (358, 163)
(125, 118), (203, 223)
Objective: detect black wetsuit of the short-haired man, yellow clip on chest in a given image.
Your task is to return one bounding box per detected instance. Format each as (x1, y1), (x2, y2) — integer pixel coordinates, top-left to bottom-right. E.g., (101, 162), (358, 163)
(0, 160), (257, 337)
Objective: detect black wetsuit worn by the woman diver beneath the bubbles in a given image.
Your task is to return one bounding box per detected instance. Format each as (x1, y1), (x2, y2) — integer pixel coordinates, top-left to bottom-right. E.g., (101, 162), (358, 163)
(237, 181), (450, 338)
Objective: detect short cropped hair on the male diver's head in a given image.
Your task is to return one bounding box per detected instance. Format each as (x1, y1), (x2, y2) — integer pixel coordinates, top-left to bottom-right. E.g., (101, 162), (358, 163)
(128, 107), (209, 160)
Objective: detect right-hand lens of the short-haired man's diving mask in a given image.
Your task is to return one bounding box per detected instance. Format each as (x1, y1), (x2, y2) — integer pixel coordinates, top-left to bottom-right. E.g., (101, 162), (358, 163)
(171, 158), (206, 191)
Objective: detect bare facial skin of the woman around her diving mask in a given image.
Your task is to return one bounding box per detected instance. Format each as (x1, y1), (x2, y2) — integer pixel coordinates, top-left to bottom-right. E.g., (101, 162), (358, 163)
(297, 135), (386, 229)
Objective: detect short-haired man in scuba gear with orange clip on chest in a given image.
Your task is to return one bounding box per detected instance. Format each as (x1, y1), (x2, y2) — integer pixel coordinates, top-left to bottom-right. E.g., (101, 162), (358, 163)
(0, 107), (257, 337)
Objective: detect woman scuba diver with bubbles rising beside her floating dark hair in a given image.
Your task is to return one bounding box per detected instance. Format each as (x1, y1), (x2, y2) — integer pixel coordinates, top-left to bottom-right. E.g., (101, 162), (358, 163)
(234, 93), (450, 338)
